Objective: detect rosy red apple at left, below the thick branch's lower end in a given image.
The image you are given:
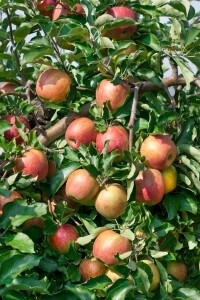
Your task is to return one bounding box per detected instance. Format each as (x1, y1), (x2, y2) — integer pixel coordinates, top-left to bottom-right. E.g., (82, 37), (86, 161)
(13, 148), (48, 181)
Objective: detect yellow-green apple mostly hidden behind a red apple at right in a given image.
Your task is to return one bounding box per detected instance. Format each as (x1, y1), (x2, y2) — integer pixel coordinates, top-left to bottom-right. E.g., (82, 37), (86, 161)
(161, 165), (177, 194)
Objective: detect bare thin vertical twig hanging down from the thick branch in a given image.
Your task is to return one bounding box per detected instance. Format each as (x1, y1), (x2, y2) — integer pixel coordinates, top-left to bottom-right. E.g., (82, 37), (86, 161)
(128, 82), (142, 151)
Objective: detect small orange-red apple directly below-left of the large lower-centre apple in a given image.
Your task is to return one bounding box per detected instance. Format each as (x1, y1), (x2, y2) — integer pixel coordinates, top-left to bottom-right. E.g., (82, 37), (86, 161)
(79, 257), (107, 282)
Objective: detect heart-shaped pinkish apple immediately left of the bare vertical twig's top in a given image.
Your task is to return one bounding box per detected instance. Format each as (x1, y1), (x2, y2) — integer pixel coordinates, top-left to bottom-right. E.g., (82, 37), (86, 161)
(95, 79), (130, 113)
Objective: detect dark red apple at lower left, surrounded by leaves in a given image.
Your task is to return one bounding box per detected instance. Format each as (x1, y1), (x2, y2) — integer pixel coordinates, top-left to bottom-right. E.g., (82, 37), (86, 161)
(48, 224), (79, 254)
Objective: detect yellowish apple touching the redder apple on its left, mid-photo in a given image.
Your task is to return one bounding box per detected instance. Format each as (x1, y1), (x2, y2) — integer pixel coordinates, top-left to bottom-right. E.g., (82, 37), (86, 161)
(95, 183), (127, 219)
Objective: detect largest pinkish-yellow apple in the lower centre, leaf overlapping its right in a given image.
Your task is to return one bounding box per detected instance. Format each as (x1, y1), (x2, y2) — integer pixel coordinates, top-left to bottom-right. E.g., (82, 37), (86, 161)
(92, 229), (132, 266)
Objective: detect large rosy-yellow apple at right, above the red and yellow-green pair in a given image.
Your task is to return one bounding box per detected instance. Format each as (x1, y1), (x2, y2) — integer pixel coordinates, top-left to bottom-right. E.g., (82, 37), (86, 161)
(140, 134), (177, 170)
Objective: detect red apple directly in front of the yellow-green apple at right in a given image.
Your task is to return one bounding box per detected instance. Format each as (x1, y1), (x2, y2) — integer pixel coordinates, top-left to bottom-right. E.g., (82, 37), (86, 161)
(135, 169), (164, 205)
